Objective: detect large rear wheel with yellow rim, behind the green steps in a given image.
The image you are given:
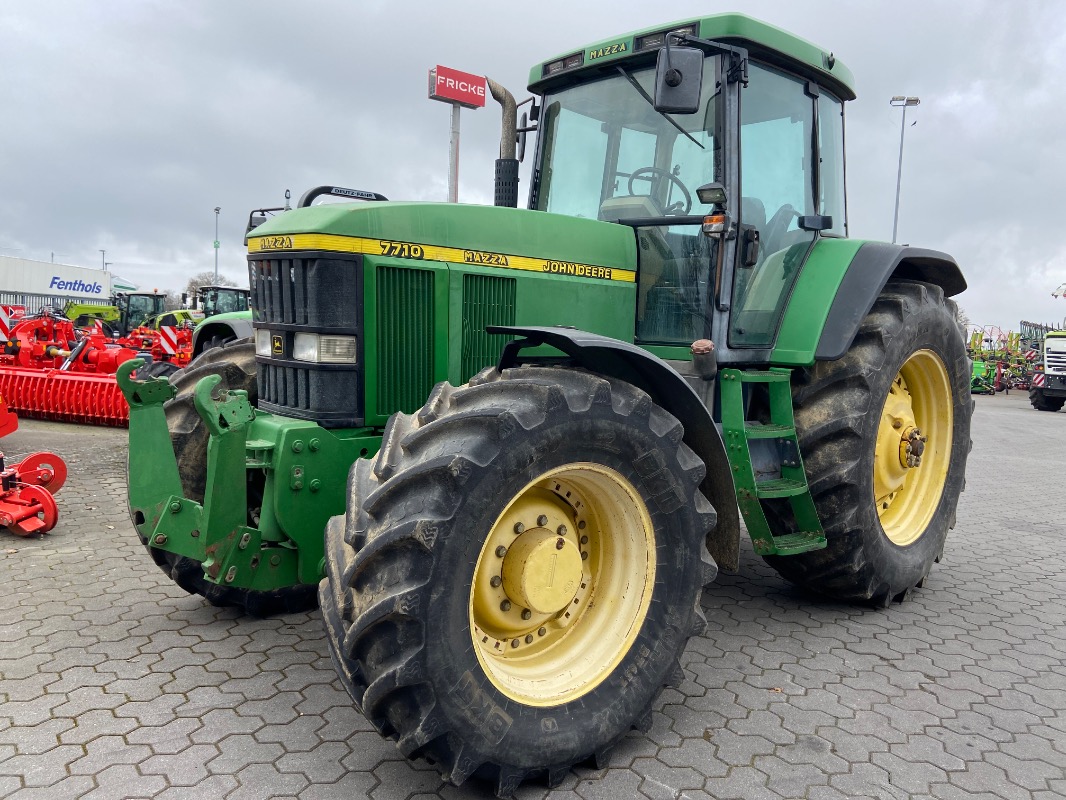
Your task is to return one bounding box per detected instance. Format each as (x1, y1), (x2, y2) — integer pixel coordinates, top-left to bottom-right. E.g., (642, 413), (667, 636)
(766, 282), (973, 606)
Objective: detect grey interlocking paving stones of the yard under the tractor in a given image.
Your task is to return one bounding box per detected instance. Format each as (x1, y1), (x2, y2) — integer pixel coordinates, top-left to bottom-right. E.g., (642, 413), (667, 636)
(0, 393), (1066, 800)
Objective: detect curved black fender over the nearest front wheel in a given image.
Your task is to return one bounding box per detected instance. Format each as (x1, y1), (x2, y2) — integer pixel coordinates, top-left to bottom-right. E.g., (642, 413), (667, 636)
(486, 325), (740, 571)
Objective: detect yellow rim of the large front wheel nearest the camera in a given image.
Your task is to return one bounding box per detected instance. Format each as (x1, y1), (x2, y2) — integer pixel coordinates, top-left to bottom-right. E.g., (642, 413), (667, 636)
(469, 462), (656, 706)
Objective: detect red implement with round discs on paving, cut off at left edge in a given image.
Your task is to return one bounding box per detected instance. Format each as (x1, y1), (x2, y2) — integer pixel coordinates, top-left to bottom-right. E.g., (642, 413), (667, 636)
(0, 399), (66, 537)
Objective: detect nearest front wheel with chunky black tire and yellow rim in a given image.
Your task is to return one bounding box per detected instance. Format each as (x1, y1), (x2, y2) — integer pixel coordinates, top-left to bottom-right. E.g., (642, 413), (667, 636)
(320, 368), (715, 797)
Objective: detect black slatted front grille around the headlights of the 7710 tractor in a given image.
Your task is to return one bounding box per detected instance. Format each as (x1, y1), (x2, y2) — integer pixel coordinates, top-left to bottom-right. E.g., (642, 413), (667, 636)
(248, 252), (364, 428)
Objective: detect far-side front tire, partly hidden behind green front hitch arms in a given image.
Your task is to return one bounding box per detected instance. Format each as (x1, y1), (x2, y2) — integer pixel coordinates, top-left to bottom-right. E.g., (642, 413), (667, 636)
(134, 339), (318, 617)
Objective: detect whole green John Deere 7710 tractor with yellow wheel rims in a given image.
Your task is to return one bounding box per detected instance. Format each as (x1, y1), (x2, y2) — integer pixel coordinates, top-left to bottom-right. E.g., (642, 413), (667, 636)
(119, 14), (972, 796)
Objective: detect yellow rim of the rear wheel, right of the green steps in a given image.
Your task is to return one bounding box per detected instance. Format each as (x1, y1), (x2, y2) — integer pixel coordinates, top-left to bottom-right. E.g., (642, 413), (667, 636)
(873, 350), (953, 547)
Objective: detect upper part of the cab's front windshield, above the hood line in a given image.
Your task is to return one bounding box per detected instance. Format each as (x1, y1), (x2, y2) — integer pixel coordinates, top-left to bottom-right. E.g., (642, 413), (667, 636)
(535, 58), (721, 220)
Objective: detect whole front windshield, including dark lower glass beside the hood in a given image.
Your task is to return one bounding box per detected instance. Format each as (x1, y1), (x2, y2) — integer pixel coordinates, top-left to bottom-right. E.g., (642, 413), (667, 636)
(533, 57), (722, 345)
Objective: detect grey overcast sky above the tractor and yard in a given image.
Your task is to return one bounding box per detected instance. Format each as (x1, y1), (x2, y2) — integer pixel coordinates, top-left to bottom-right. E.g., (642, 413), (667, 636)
(0, 0), (1066, 330)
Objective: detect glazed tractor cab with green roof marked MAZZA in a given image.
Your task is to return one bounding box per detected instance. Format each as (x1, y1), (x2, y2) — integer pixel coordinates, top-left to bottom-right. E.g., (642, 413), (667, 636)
(530, 15), (854, 362)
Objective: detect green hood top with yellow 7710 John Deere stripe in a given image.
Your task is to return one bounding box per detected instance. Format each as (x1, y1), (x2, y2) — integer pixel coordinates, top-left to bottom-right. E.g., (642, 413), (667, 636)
(248, 202), (636, 272)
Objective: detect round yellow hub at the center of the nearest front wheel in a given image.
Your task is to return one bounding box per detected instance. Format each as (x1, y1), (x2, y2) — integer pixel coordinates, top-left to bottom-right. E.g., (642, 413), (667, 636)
(502, 526), (581, 614)
